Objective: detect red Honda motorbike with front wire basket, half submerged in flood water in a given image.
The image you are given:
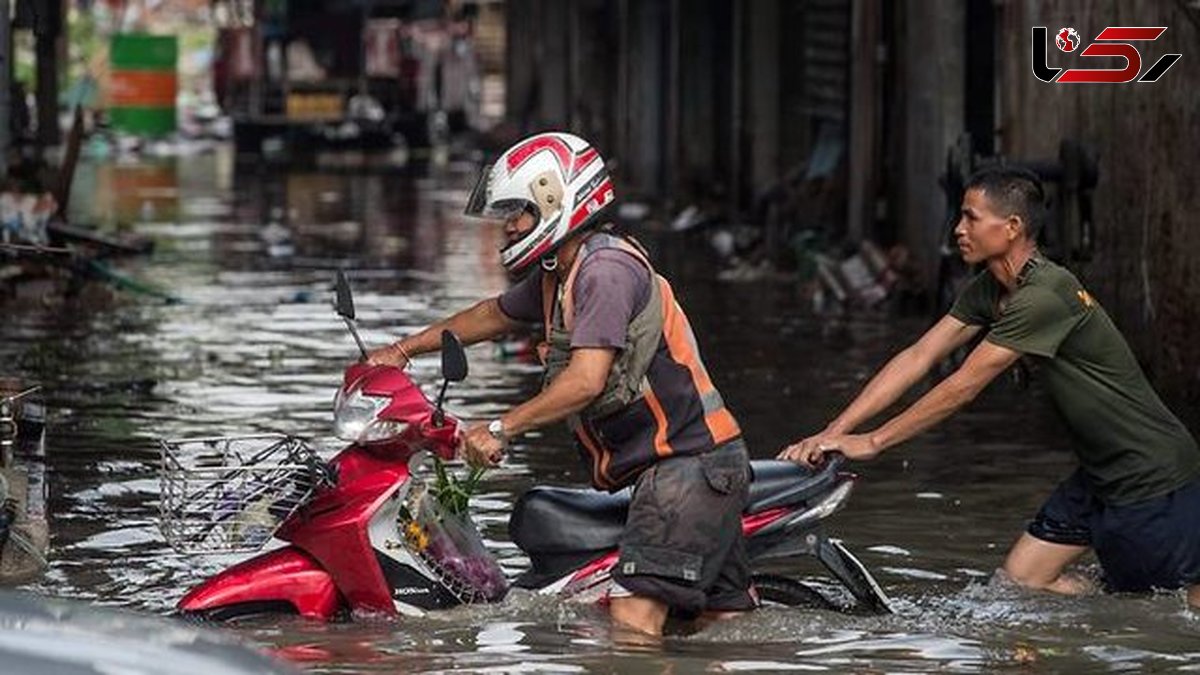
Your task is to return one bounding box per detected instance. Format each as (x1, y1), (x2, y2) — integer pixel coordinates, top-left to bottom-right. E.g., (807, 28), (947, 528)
(161, 274), (890, 620)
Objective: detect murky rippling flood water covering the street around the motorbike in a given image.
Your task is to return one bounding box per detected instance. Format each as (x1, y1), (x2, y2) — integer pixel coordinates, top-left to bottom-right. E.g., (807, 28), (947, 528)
(0, 153), (1200, 673)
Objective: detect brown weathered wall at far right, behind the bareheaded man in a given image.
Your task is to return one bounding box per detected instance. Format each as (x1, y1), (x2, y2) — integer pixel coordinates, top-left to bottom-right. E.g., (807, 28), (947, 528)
(997, 0), (1200, 420)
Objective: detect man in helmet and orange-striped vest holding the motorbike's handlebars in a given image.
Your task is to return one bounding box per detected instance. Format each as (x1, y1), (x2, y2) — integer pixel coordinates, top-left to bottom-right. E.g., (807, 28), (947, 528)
(370, 133), (757, 635)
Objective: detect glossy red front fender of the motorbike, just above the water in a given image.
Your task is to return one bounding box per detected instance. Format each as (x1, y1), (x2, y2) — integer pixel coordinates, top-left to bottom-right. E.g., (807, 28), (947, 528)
(175, 546), (342, 621)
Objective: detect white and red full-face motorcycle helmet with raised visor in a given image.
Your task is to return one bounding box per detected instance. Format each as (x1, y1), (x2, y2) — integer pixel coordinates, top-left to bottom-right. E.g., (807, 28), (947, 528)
(466, 132), (613, 273)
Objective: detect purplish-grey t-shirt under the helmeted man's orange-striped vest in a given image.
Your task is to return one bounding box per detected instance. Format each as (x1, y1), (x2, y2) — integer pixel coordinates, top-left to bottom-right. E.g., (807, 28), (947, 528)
(499, 249), (650, 350)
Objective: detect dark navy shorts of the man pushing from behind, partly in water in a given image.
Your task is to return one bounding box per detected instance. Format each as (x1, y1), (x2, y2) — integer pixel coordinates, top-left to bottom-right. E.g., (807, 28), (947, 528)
(1028, 471), (1200, 592)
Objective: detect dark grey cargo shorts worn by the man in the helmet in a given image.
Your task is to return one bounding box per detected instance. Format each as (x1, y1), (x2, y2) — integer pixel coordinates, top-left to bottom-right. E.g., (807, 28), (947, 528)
(613, 440), (757, 616)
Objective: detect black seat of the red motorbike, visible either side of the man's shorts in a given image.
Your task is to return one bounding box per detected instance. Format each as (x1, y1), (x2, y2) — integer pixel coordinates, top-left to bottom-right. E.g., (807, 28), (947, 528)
(509, 458), (841, 554)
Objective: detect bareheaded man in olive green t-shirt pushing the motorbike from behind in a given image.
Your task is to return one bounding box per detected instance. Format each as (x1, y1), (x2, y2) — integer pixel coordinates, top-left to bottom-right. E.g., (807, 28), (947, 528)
(780, 168), (1200, 607)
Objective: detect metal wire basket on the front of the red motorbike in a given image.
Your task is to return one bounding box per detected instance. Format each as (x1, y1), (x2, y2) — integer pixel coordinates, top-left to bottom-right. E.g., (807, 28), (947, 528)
(158, 434), (331, 552)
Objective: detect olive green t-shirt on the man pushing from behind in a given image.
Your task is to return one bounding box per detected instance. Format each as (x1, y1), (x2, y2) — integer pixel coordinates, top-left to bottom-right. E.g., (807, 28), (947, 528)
(950, 257), (1200, 504)
